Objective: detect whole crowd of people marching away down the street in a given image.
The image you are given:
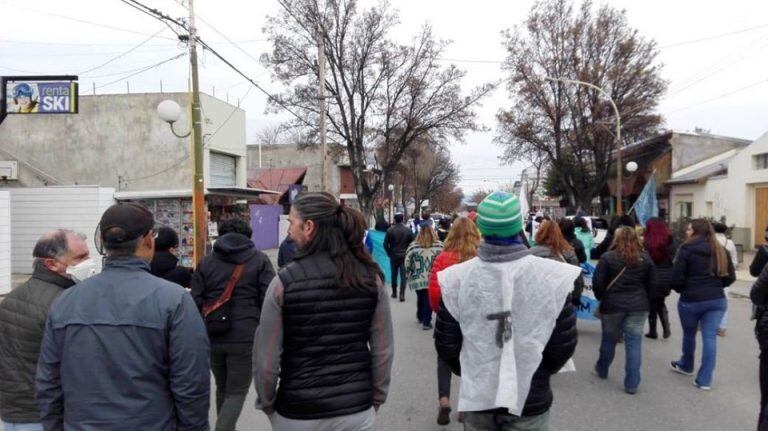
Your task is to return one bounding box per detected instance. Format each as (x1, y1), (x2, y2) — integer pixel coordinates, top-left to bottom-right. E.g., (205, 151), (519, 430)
(0, 191), (768, 431)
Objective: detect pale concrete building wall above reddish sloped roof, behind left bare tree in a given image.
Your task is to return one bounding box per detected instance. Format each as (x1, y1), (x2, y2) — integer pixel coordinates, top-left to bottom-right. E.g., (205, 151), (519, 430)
(248, 144), (341, 197)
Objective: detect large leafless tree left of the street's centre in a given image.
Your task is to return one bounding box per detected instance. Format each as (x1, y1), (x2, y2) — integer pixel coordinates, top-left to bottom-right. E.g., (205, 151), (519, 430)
(262, 0), (493, 214)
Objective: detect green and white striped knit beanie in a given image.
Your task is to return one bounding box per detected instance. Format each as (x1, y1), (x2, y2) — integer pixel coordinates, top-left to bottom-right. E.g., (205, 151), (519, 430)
(475, 191), (523, 238)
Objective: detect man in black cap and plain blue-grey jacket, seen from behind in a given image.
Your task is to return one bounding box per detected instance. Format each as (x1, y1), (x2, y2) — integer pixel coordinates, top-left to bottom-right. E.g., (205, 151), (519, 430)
(35, 203), (210, 431)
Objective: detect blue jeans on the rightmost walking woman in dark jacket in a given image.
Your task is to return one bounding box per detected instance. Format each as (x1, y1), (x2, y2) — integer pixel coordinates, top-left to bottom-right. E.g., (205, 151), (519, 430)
(677, 298), (728, 386)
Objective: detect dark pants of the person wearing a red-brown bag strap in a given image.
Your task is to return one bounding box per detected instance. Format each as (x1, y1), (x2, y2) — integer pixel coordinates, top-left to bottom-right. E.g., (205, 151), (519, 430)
(211, 343), (253, 431)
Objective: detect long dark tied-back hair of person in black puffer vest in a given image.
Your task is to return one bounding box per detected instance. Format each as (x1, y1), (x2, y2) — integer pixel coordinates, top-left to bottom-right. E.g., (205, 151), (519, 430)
(293, 193), (384, 289)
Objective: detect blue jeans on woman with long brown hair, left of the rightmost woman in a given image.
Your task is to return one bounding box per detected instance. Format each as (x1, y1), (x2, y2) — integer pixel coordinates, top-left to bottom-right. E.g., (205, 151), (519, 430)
(595, 311), (648, 391)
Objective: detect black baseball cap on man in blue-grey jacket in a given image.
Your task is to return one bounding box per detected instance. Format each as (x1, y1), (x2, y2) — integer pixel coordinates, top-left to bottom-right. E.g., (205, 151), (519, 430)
(99, 202), (155, 244)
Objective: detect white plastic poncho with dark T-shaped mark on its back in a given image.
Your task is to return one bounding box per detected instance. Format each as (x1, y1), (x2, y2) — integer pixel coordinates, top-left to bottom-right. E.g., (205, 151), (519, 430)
(437, 256), (581, 416)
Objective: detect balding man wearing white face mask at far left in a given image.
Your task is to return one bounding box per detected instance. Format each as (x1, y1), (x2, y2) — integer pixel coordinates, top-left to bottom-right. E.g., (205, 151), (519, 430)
(0, 230), (95, 431)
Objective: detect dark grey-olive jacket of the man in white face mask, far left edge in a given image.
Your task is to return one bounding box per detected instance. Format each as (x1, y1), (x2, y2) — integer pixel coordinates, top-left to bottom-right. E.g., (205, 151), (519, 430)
(0, 261), (75, 423)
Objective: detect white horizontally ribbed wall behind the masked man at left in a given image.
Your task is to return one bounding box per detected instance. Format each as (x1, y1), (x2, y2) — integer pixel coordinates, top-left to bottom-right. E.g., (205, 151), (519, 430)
(4, 186), (115, 274)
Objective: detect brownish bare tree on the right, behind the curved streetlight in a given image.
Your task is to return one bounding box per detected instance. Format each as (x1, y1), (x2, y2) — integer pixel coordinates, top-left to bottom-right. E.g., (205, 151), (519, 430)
(496, 0), (667, 208)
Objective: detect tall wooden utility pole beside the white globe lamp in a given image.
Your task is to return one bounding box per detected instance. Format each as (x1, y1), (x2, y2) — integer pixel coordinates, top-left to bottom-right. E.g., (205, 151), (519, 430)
(189, 0), (208, 266)
